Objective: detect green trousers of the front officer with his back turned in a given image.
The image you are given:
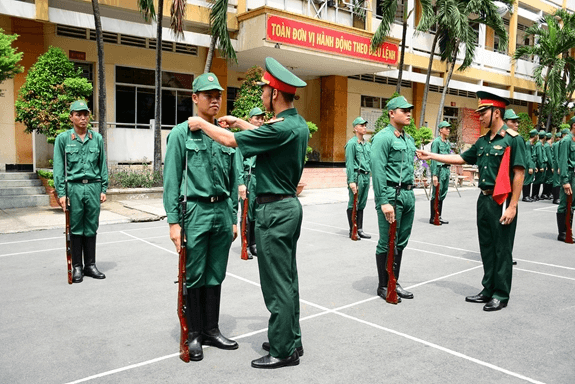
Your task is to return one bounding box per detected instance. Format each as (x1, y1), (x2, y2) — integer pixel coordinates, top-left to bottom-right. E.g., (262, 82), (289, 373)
(256, 197), (303, 358)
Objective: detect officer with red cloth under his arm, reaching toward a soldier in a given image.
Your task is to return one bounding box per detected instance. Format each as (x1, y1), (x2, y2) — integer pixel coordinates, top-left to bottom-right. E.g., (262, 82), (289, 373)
(418, 91), (525, 311)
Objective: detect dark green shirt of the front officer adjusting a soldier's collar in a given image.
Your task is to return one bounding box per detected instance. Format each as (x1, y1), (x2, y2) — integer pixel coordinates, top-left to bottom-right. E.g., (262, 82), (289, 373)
(234, 108), (309, 196)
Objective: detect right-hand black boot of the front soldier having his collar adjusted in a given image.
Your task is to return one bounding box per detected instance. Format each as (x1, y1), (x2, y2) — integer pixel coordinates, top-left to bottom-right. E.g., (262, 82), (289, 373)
(201, 285), (238, 349)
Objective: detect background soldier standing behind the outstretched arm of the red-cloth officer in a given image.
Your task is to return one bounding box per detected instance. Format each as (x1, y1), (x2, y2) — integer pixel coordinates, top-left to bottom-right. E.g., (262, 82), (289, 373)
(429, 121), (451, 224)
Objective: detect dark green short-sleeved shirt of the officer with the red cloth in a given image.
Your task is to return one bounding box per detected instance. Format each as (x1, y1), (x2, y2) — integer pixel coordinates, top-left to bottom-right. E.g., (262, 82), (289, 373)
(461, 124), (525, 189)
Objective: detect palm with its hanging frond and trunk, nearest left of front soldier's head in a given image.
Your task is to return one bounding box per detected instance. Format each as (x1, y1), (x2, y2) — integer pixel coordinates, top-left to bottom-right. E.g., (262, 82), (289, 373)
(138, 0), (164, 172)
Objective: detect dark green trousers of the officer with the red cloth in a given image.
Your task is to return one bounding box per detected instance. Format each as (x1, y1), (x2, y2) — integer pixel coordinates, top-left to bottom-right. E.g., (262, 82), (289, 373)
(477, 193), (519, 303)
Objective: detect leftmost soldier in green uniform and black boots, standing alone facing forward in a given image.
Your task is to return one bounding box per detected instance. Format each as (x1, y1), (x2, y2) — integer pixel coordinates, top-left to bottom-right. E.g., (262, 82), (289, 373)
(54, 100), (108, 283)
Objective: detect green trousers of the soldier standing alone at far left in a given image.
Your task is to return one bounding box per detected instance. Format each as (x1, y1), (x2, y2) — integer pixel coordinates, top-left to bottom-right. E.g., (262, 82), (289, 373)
(68, 182), (102, 237)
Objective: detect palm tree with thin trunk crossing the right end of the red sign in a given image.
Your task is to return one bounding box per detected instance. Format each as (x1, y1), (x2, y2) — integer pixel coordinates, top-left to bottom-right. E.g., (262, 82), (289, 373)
(370, 0), (433, 93)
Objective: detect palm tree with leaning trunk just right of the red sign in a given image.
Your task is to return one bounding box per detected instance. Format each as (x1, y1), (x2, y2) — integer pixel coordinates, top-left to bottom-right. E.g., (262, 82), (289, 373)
(435, 0), (513, 127)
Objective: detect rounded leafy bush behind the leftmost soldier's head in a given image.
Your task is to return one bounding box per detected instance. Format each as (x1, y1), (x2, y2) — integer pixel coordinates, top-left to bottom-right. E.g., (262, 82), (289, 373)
(16, 47), (92, 143)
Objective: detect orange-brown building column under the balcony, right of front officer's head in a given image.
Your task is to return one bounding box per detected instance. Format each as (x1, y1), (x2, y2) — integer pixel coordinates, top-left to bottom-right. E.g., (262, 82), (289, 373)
(318, 76), (347, 163)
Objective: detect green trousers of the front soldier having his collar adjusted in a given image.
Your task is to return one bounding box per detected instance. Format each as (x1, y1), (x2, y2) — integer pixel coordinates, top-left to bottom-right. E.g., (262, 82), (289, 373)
(185, 199), (235, 288)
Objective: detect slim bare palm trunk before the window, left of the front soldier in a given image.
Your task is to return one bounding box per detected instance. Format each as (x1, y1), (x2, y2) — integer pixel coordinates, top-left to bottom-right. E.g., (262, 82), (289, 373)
(154, 0), (164, 172)
